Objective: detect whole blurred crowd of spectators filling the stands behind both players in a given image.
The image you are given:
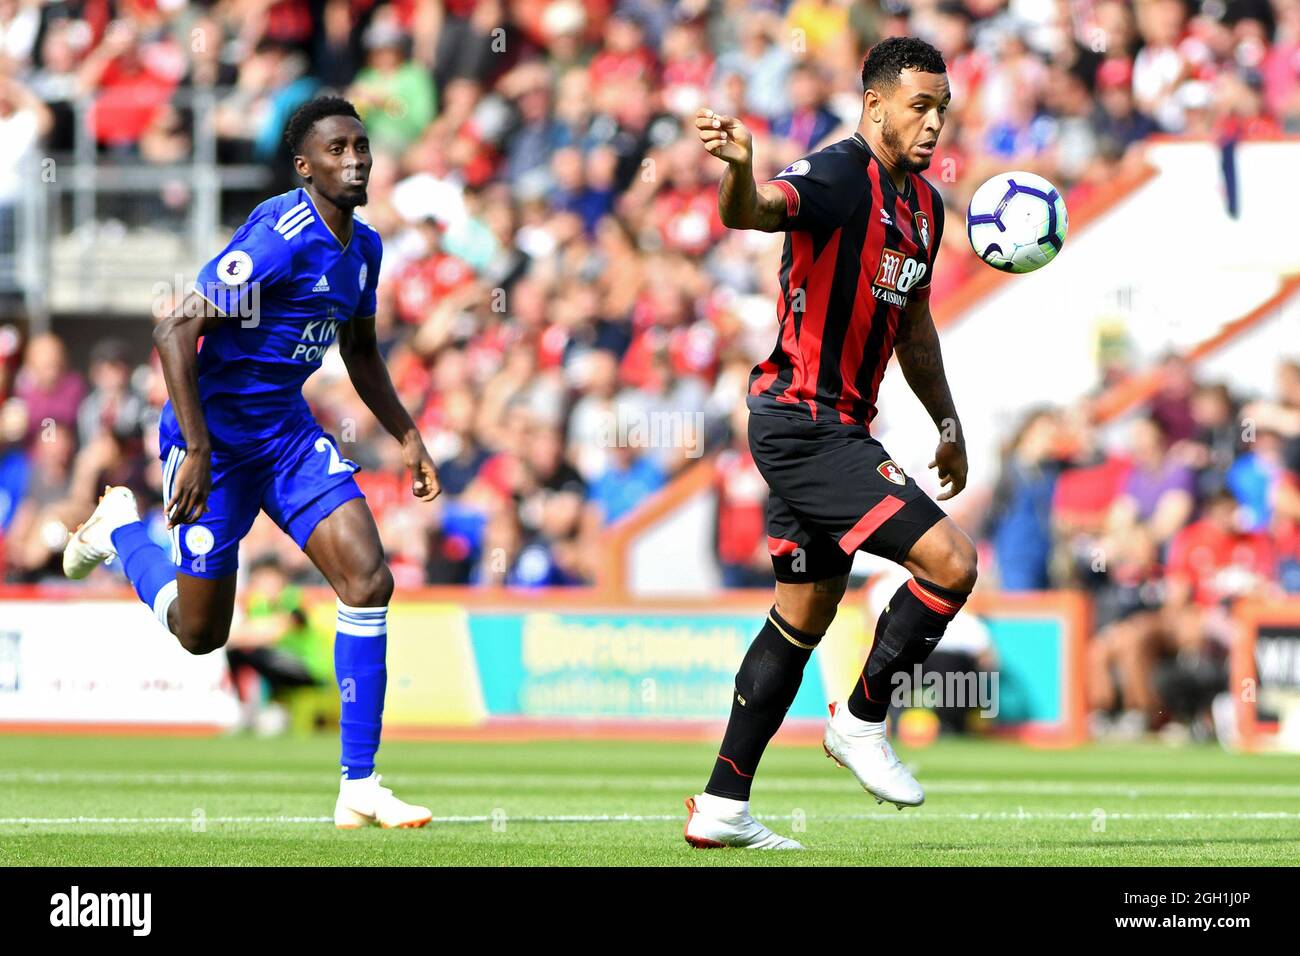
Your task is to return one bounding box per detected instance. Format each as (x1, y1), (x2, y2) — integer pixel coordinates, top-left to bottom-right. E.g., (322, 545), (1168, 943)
(0, 0), (1300, 723)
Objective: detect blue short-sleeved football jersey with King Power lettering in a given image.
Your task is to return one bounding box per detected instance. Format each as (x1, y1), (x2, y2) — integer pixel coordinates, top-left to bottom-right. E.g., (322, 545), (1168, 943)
(160, 187), (384, 453)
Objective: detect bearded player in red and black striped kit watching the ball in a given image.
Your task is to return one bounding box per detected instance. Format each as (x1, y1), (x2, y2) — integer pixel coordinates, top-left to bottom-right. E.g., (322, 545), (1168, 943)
(686, 36), (975, 849)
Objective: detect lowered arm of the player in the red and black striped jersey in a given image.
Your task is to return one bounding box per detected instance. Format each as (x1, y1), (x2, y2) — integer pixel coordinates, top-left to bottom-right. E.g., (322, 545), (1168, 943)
(894, 295), (967, 501)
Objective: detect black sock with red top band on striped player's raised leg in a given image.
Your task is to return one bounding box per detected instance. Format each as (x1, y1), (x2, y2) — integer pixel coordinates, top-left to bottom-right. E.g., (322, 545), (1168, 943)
(848, 578), (967, 721)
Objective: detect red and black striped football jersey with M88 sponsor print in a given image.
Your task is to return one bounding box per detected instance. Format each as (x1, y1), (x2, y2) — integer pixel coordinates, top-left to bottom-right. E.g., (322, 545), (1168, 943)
(748, 133), (944, 425)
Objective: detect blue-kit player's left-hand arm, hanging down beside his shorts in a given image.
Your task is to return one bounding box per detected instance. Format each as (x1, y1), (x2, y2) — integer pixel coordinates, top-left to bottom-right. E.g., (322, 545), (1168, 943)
(153, 291), (220, 528)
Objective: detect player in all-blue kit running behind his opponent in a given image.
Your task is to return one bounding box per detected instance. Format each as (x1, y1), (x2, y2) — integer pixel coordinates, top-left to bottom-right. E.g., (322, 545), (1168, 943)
(64, 98), (441, 827)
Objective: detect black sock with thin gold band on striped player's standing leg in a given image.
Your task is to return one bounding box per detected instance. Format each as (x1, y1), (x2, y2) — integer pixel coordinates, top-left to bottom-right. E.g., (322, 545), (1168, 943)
(705, 607), (822, 800)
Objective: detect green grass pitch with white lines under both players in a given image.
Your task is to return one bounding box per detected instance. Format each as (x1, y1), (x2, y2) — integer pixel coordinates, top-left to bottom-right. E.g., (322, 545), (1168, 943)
(0, 736), (1300, 866)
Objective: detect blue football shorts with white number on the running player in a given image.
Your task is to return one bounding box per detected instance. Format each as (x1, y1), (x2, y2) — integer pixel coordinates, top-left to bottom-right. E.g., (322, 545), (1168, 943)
(160, 419), (365, 578)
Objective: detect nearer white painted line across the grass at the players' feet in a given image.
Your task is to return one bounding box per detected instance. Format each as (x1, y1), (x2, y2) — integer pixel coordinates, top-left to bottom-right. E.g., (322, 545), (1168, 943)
(0, 808), (1300, 826)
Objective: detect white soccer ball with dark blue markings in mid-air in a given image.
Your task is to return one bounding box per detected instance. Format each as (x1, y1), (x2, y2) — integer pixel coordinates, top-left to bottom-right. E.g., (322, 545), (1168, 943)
(966, 172), (1070, 272)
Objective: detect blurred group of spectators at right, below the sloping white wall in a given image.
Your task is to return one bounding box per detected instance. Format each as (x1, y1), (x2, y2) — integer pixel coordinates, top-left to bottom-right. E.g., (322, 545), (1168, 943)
(983, 358), (1300, 740)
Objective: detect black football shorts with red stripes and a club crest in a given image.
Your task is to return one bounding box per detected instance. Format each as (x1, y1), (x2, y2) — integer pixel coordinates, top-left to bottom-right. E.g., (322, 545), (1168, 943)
(749, 415), (945, 583)
